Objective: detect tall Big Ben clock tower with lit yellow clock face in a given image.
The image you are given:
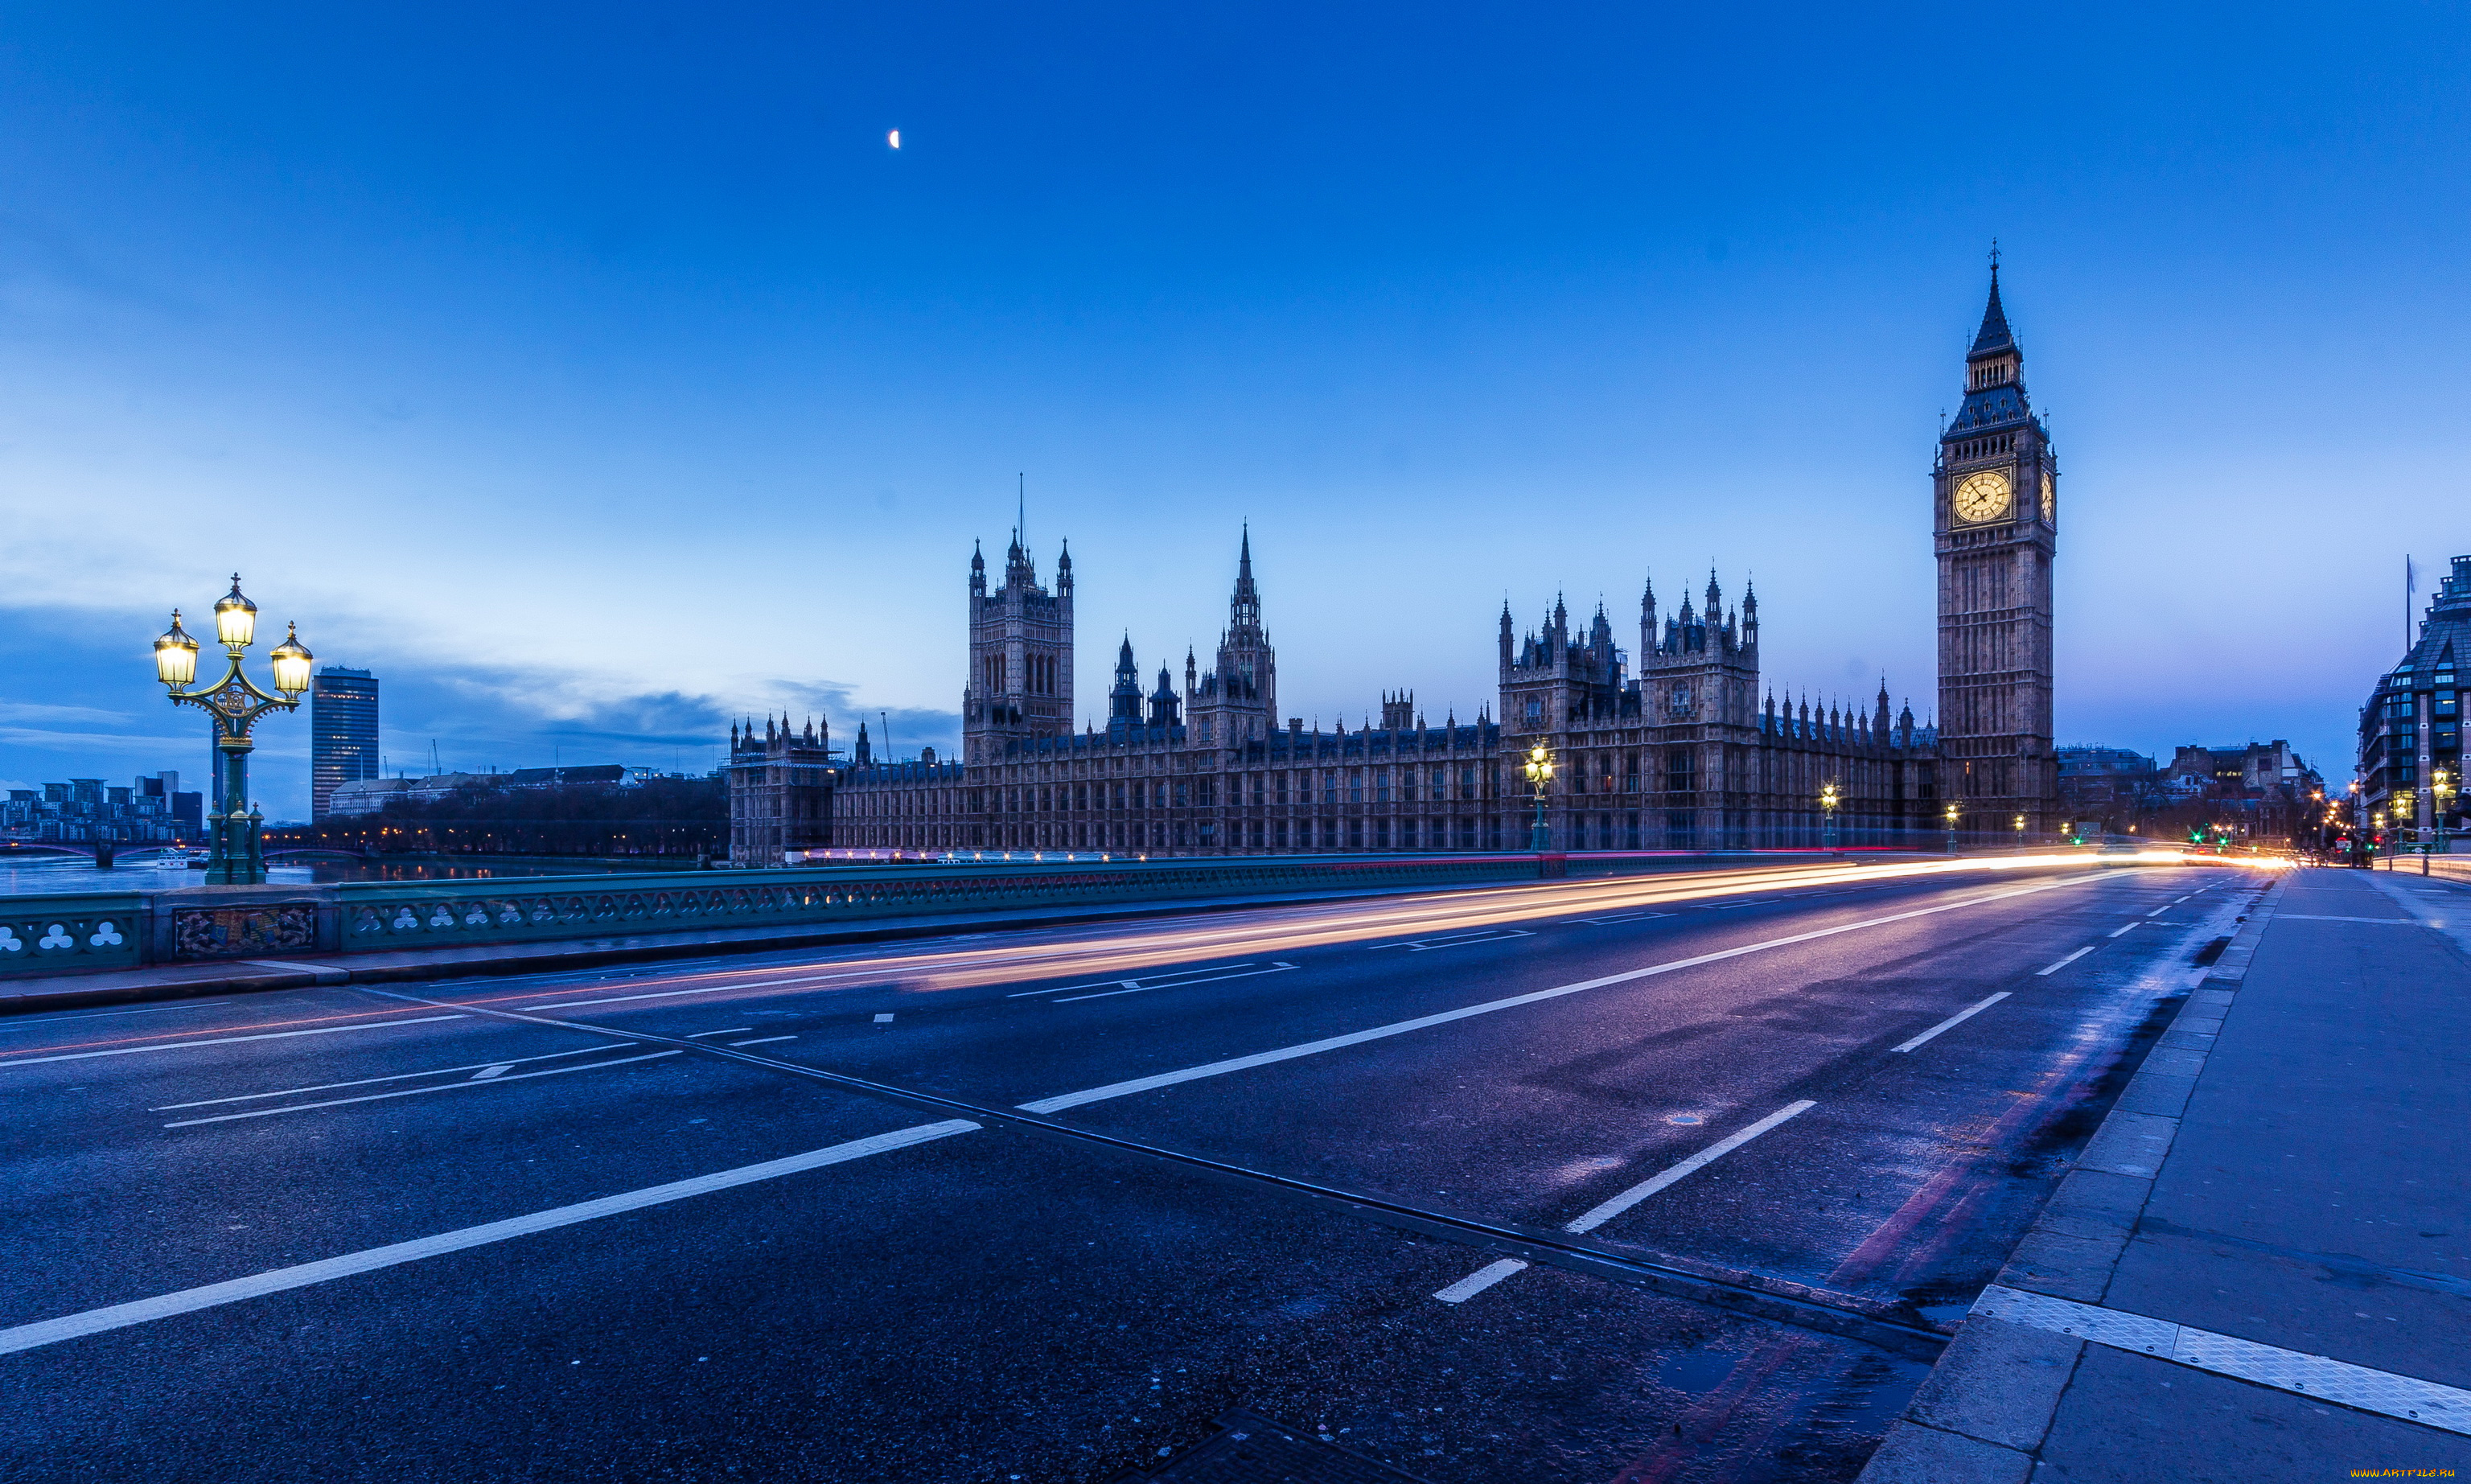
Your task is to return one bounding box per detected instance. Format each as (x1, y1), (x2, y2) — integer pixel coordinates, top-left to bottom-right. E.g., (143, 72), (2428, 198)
(1930, 254), (2058, 835)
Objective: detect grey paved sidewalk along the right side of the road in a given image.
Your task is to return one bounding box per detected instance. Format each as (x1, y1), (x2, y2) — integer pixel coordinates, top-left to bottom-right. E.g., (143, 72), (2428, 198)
(1860, 869), (2471, 1484)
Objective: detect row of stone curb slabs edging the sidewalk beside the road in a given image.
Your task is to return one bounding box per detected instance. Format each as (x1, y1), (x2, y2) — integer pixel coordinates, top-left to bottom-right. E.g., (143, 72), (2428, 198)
(1856, 879), (2280, 1484)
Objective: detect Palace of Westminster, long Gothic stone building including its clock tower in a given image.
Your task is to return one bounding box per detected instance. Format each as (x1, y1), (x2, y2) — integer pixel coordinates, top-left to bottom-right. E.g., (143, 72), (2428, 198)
(729, 264), (2058, 864)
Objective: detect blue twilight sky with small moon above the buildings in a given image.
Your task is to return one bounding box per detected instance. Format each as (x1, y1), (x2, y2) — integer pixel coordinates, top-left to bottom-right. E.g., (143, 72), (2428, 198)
(0, 2), (2471, 817)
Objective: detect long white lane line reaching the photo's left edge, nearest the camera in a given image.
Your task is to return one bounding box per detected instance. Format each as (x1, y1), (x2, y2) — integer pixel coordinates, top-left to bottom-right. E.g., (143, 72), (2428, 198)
(0, 1119), (979, 1355)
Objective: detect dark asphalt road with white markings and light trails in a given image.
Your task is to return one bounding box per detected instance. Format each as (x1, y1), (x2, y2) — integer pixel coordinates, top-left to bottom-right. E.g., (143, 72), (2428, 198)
(0, 849), (2259, 1484)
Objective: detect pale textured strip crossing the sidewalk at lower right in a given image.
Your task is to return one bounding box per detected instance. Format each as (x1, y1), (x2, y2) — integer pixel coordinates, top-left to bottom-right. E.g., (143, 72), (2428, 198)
(1971, 1284), (2471, 1435)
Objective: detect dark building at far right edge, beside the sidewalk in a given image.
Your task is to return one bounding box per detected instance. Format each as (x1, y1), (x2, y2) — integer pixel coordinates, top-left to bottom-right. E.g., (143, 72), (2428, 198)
(2360, 556), (2471, 835)
